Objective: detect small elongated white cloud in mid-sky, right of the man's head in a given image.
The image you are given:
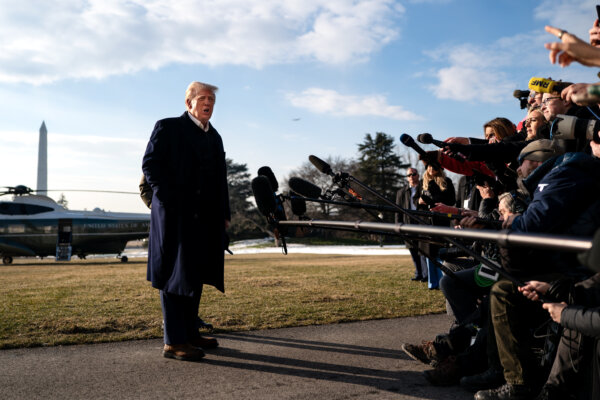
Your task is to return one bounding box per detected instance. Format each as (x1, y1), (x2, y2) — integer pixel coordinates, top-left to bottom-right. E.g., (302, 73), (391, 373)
(286, 88), (421, 121)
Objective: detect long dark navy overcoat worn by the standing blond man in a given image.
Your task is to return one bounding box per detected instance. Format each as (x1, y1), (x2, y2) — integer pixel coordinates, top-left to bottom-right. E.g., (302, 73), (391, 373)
(142, 112), (231, 296)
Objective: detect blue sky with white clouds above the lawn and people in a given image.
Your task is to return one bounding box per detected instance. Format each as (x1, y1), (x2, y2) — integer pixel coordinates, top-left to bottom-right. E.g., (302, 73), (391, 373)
(0, 0), (598, 212)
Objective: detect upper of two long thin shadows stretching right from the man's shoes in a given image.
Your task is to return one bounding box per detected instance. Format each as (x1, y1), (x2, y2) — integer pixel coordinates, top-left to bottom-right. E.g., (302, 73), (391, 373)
(219, 333), (408, 359)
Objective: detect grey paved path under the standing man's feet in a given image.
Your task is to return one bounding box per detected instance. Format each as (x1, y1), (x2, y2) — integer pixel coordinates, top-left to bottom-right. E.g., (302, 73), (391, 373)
(0, 315), (473, 400)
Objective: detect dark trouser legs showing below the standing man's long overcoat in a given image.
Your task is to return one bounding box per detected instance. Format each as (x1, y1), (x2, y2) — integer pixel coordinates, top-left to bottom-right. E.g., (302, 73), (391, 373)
(160, 290), (202, 345)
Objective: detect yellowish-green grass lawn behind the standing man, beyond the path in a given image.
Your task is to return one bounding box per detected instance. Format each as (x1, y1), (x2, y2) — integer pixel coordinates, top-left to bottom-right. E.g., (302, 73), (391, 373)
(0, 254), (445, 349)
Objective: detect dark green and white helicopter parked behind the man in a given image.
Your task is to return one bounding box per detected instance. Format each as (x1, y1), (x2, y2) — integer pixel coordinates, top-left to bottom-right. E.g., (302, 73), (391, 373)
(0, 185), (150, 265)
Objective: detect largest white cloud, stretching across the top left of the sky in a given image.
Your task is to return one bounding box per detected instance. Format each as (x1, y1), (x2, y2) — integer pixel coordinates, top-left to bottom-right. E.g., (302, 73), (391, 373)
(0, 0), (404, 84)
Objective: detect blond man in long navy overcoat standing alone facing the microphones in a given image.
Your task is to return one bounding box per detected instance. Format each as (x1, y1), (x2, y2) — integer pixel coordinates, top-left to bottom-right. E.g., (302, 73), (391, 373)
(142, 82), (231, 360)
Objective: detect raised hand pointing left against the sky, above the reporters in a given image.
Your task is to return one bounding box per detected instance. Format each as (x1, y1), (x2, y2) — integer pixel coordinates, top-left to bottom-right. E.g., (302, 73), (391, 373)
(544, 26), (600, 67)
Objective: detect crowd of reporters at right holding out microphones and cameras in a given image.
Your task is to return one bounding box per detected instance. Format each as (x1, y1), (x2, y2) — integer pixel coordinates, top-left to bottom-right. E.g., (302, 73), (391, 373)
(397, 12), (600, 400)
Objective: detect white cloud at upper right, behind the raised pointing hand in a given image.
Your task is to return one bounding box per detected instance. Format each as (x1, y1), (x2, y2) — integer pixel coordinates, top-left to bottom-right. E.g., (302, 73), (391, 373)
(426, 0), (596, 103)
